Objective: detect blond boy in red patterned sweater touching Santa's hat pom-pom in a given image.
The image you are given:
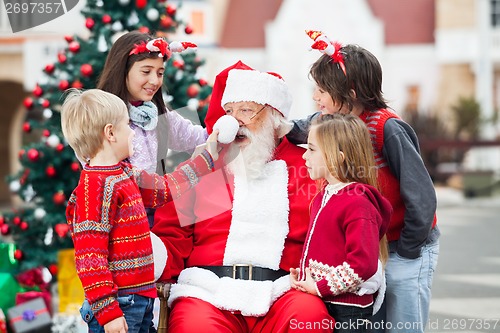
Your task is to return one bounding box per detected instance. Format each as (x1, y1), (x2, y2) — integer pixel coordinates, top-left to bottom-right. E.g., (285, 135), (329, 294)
(61, 89), (218, 333)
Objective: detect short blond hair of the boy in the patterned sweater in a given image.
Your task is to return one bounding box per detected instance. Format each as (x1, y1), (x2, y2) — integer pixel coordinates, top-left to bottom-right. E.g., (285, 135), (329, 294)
(61, 89), (128, 161)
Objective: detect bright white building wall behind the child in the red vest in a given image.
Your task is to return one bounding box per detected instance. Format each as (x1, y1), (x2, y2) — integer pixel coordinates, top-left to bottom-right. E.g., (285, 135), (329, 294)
(264, 0), (384, 118)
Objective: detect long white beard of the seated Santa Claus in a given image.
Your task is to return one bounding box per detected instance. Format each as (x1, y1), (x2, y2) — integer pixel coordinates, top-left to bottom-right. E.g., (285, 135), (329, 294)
(227, 117), (276, 179)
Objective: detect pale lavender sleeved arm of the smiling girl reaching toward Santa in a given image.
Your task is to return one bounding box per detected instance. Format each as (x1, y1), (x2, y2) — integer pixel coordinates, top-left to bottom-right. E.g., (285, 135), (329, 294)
(165, 111), (208, 151)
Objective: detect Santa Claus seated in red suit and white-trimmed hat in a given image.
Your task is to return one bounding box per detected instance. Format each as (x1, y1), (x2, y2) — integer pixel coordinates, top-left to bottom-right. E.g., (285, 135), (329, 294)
(152, 62), (334, 333)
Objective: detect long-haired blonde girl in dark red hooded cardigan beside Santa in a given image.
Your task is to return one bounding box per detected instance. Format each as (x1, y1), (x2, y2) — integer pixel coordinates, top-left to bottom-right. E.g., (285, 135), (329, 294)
(290, 114), (392, 333)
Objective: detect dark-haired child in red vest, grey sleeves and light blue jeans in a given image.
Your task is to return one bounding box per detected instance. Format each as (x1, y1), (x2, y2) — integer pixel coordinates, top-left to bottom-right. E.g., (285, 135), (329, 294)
(287, 31), (440, 332)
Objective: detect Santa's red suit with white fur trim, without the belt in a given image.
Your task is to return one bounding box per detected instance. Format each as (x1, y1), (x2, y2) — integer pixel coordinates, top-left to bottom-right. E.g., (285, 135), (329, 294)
(152, 138), (333, 332)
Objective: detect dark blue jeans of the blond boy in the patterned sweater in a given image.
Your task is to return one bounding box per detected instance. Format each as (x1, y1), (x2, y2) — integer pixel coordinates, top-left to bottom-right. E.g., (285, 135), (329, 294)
(80, 294), (154, 333)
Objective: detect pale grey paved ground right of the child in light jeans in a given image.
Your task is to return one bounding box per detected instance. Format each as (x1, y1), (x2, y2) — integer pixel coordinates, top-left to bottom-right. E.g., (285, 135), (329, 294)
(426, 188), (500, 333)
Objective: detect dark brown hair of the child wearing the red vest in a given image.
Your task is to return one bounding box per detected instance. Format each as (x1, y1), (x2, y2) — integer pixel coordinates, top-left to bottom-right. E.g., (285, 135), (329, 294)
(309, 44), (388, 111)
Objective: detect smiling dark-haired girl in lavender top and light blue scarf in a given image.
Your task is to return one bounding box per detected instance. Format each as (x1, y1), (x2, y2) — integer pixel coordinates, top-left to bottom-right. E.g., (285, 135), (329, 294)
(97, 31), (208, 174)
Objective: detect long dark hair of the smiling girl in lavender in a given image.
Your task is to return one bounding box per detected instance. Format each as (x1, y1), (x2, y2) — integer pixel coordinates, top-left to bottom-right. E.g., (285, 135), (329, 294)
(97, 31), (167, 114)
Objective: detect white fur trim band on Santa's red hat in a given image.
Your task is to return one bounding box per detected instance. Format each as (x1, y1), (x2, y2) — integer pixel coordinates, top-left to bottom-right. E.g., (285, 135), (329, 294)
(221, 69), (292, 119)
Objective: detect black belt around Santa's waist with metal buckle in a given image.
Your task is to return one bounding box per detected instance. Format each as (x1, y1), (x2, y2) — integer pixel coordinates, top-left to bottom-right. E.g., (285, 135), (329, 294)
(198, 265), (288, 281)
